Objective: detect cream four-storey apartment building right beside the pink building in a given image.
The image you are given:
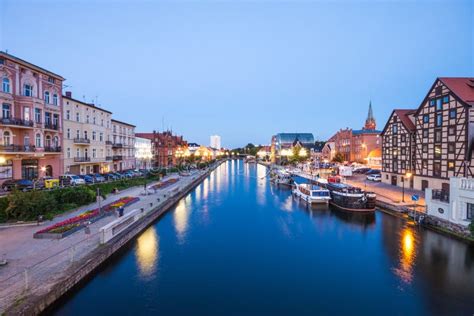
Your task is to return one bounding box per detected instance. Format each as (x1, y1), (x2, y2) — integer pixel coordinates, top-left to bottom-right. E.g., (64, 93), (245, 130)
(63, 91), (112, 174)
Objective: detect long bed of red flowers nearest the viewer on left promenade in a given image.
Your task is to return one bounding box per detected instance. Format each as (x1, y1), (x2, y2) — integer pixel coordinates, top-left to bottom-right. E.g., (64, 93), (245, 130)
(33, 196), (140, 239)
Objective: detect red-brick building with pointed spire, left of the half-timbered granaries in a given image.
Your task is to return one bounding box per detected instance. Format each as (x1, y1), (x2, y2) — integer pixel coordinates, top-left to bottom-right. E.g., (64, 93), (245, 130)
(331, 103), (382, 163)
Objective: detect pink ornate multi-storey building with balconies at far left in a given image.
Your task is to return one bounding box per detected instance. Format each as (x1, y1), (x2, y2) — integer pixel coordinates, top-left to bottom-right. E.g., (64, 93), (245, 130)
(0, 52), (64, 182)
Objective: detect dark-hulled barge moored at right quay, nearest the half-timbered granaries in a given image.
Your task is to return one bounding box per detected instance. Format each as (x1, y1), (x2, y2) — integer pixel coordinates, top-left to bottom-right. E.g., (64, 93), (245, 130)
(317, 179), (377, 212)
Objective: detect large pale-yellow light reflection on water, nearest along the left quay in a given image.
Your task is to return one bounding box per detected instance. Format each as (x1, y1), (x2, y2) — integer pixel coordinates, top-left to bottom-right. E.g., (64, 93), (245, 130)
(135, 226), (160, 277)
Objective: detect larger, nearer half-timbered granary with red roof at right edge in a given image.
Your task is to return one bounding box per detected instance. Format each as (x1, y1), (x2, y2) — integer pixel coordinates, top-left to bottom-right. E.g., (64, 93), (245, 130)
(414, 78), (474, 192)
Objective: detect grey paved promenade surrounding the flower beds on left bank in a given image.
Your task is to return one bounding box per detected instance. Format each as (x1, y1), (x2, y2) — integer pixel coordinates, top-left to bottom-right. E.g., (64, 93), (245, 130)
(0, 171), (202, 314)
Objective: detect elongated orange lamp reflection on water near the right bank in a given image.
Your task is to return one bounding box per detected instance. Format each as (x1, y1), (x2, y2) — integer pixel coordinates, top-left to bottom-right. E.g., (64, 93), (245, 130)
(395, 227), (416, 284)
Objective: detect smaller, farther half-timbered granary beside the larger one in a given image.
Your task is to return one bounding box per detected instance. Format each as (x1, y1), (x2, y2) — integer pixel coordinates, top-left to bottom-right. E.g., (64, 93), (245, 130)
(381, 110), (416, 188)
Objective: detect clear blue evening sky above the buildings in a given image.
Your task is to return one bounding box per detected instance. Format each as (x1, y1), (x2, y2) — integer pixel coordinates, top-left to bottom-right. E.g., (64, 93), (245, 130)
(0, 0), (474, 147)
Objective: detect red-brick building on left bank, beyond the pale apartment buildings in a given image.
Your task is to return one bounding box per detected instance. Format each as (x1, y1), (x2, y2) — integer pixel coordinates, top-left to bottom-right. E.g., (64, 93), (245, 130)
(136, 131), (188, 168)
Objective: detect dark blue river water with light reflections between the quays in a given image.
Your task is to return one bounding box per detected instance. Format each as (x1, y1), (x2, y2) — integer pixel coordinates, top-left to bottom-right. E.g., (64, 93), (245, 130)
(49, 160), (474, 315)
